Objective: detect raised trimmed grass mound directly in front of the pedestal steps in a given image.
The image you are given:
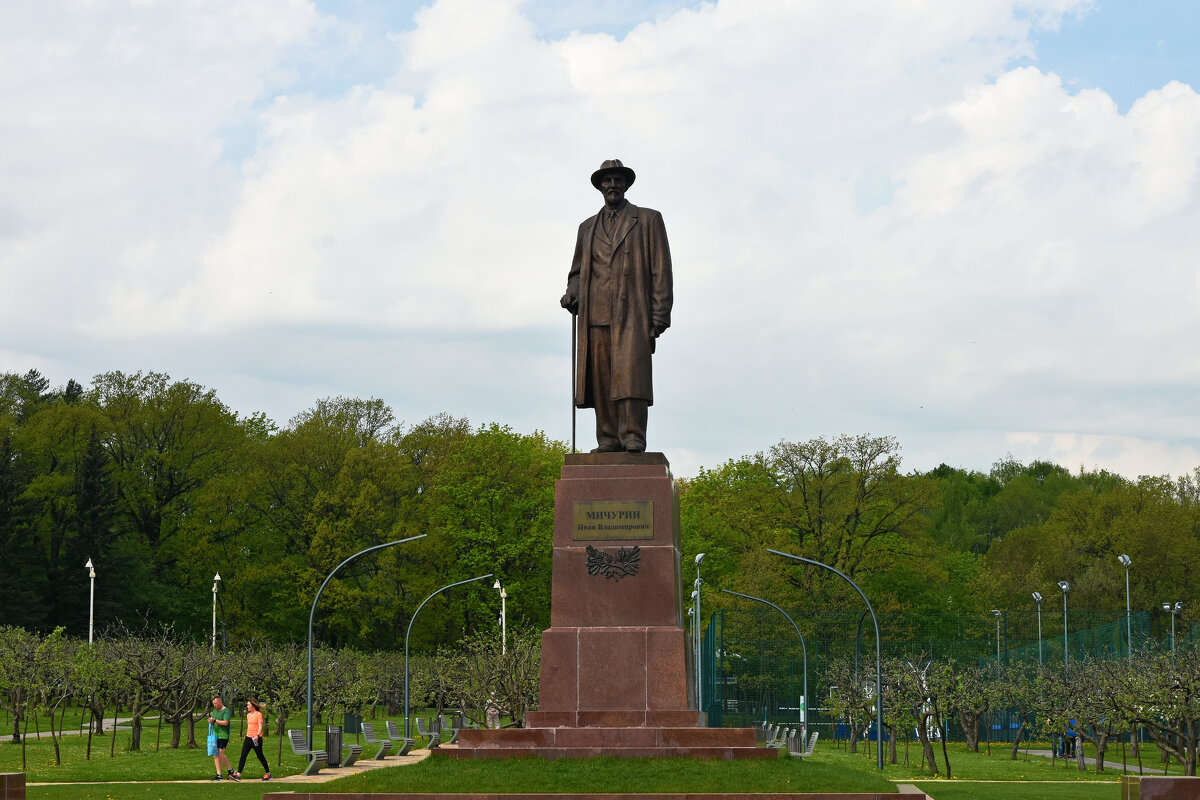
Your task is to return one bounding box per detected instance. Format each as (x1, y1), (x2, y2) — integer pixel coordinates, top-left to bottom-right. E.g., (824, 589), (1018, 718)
(304, 758), (896, 793)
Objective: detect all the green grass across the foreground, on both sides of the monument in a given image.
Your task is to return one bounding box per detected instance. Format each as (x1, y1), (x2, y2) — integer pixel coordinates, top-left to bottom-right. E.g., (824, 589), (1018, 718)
(0, 720), (1180, 800)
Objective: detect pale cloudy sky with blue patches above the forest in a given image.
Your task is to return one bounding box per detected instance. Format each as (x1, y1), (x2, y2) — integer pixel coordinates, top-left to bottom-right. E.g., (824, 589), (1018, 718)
(0, 0), (1200, 476)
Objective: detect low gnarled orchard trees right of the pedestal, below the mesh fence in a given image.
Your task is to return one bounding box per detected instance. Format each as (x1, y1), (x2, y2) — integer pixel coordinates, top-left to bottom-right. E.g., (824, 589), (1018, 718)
(827, 645), (1200, 777)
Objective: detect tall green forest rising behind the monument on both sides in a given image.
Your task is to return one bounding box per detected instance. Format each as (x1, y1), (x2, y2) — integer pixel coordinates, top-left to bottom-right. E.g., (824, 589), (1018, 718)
(0, 371), (1200, 650)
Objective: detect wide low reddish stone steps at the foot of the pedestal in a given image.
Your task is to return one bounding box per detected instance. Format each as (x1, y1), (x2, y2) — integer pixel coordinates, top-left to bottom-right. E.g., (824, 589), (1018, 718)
(433, 724), (780, 760)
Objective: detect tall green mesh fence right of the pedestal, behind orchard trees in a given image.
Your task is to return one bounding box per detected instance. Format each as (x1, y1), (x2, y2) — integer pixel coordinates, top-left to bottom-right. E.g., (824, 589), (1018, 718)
(701, 606), (1156, 741)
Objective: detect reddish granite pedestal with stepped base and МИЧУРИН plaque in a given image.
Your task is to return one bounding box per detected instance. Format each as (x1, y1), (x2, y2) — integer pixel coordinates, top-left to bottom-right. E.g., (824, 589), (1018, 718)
(444, 453), (779, 758)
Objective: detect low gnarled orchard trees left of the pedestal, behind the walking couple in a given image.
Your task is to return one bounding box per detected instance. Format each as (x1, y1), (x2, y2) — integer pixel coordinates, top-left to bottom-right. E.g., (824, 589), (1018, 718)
(0, 625), (541, 769)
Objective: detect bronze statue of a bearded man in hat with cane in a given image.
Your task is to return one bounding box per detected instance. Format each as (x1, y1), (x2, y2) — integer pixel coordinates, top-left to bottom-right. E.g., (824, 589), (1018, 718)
(562, 158), (672, 452)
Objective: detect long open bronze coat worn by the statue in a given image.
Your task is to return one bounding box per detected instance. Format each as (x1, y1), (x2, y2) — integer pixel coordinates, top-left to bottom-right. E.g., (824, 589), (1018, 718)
(566, 203), (672, 408)
